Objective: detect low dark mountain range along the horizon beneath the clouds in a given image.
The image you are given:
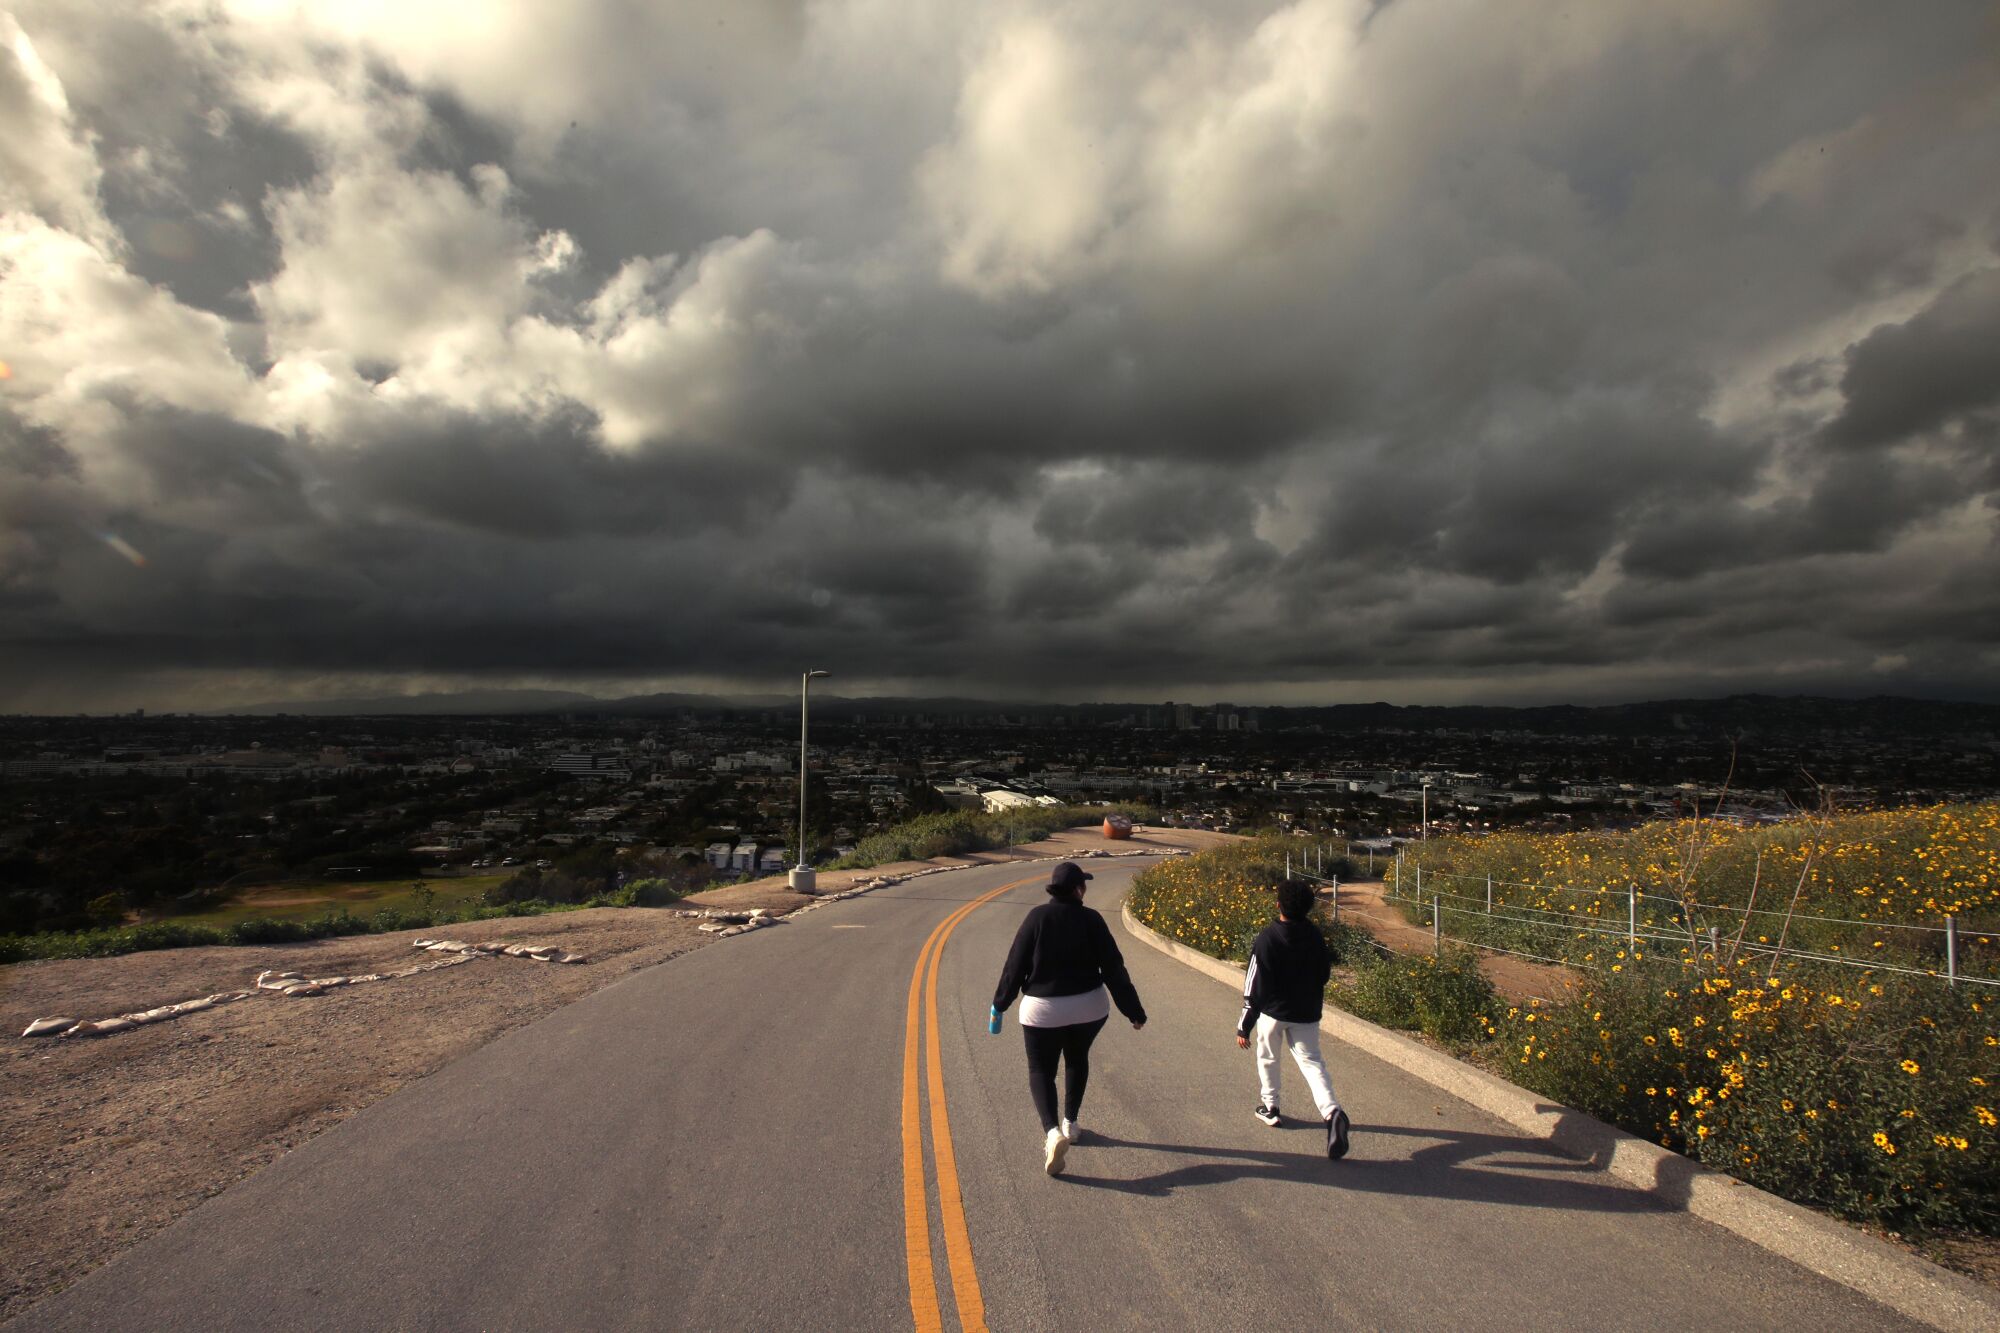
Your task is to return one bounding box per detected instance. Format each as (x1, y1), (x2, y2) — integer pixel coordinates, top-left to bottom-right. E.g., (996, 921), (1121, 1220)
(215, 691), (2000, 739)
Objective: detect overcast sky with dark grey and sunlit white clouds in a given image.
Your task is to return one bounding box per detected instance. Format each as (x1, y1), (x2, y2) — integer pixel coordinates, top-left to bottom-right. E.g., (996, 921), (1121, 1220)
(0, 0), (2000, 711)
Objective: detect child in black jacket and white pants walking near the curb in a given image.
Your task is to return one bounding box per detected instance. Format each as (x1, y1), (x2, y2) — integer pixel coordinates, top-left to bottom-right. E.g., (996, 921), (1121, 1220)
(1236, 879), (1348, 1159)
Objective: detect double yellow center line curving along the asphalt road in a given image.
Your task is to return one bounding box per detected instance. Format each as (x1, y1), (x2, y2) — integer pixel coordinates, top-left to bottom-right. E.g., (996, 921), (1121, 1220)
(902, 875), (1038, 1333)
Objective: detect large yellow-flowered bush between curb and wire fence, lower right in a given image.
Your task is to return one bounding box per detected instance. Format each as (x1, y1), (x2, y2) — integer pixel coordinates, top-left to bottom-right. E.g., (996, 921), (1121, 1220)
(1486, 969), (2000, 1233)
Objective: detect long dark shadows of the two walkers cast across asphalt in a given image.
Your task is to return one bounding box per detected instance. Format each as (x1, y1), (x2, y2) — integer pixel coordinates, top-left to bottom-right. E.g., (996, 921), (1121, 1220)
(1058, 1125), (1668, 1213)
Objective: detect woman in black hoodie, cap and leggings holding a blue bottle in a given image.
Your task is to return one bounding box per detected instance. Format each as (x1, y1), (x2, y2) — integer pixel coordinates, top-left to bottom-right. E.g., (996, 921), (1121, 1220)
(994, 861), (1146, 1175)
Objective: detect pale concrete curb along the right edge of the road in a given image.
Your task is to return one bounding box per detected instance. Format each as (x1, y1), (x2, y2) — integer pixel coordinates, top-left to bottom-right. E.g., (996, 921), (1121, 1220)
(1122, 907), (2000, 1333)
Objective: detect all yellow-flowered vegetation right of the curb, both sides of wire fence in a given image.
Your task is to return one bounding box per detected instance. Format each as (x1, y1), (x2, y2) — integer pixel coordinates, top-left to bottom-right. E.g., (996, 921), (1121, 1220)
(1130, 805), (2000, 1235)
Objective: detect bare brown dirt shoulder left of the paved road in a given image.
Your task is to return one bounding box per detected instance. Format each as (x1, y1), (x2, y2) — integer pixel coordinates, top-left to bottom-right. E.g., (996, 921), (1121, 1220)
(0, 909), (712, 1319)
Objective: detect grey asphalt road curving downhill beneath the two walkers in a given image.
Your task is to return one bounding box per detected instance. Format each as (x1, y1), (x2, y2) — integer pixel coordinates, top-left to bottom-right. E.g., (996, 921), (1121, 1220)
(10, 863), (1914, 1333)
